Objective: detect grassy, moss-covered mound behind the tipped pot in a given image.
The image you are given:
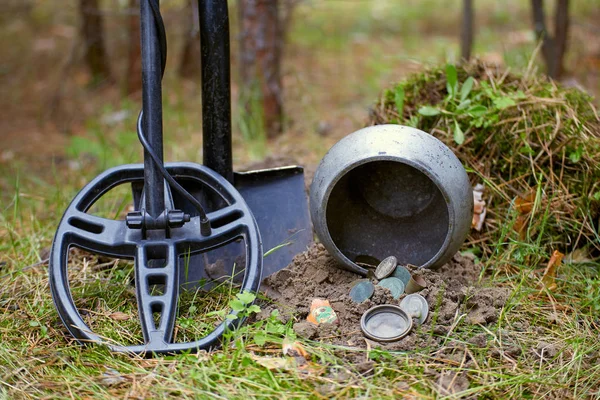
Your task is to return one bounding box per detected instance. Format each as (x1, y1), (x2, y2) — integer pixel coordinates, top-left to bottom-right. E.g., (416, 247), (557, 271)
(370, 63), (600, 256)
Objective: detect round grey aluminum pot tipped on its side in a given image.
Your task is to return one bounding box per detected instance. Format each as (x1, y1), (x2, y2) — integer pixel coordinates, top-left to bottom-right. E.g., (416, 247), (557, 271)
(310, 125), (473, 275)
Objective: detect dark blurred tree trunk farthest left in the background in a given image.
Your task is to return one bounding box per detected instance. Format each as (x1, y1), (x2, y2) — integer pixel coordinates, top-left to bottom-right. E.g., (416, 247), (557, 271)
(79, 0), (111, 85)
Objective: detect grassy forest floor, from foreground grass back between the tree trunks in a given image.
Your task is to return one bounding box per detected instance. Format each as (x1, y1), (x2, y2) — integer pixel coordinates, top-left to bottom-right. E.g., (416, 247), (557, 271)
(0, 0), (600, 399)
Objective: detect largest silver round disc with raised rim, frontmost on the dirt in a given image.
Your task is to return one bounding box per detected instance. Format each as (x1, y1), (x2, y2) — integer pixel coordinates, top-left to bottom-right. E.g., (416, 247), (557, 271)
(360, 304), (412, 342)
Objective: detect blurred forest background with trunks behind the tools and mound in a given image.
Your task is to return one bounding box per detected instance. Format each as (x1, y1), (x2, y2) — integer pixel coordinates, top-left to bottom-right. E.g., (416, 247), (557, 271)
(0, 0), (600, 173)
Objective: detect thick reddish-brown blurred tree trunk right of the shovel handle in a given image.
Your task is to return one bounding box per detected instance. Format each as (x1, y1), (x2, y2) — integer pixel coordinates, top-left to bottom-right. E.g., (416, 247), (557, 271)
(239, 0), (283, 137)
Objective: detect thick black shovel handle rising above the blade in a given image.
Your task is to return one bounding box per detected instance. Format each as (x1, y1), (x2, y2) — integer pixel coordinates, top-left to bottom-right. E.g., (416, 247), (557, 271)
(198, 0), (233, 182)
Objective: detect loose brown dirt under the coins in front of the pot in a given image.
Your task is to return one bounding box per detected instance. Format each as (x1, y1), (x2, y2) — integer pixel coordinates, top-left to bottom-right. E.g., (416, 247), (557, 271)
(257, 244), (509, 350)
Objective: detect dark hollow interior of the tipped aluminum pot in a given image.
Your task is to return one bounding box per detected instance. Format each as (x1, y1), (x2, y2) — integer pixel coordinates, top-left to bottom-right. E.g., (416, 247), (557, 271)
(326, 160), (450, 266)
